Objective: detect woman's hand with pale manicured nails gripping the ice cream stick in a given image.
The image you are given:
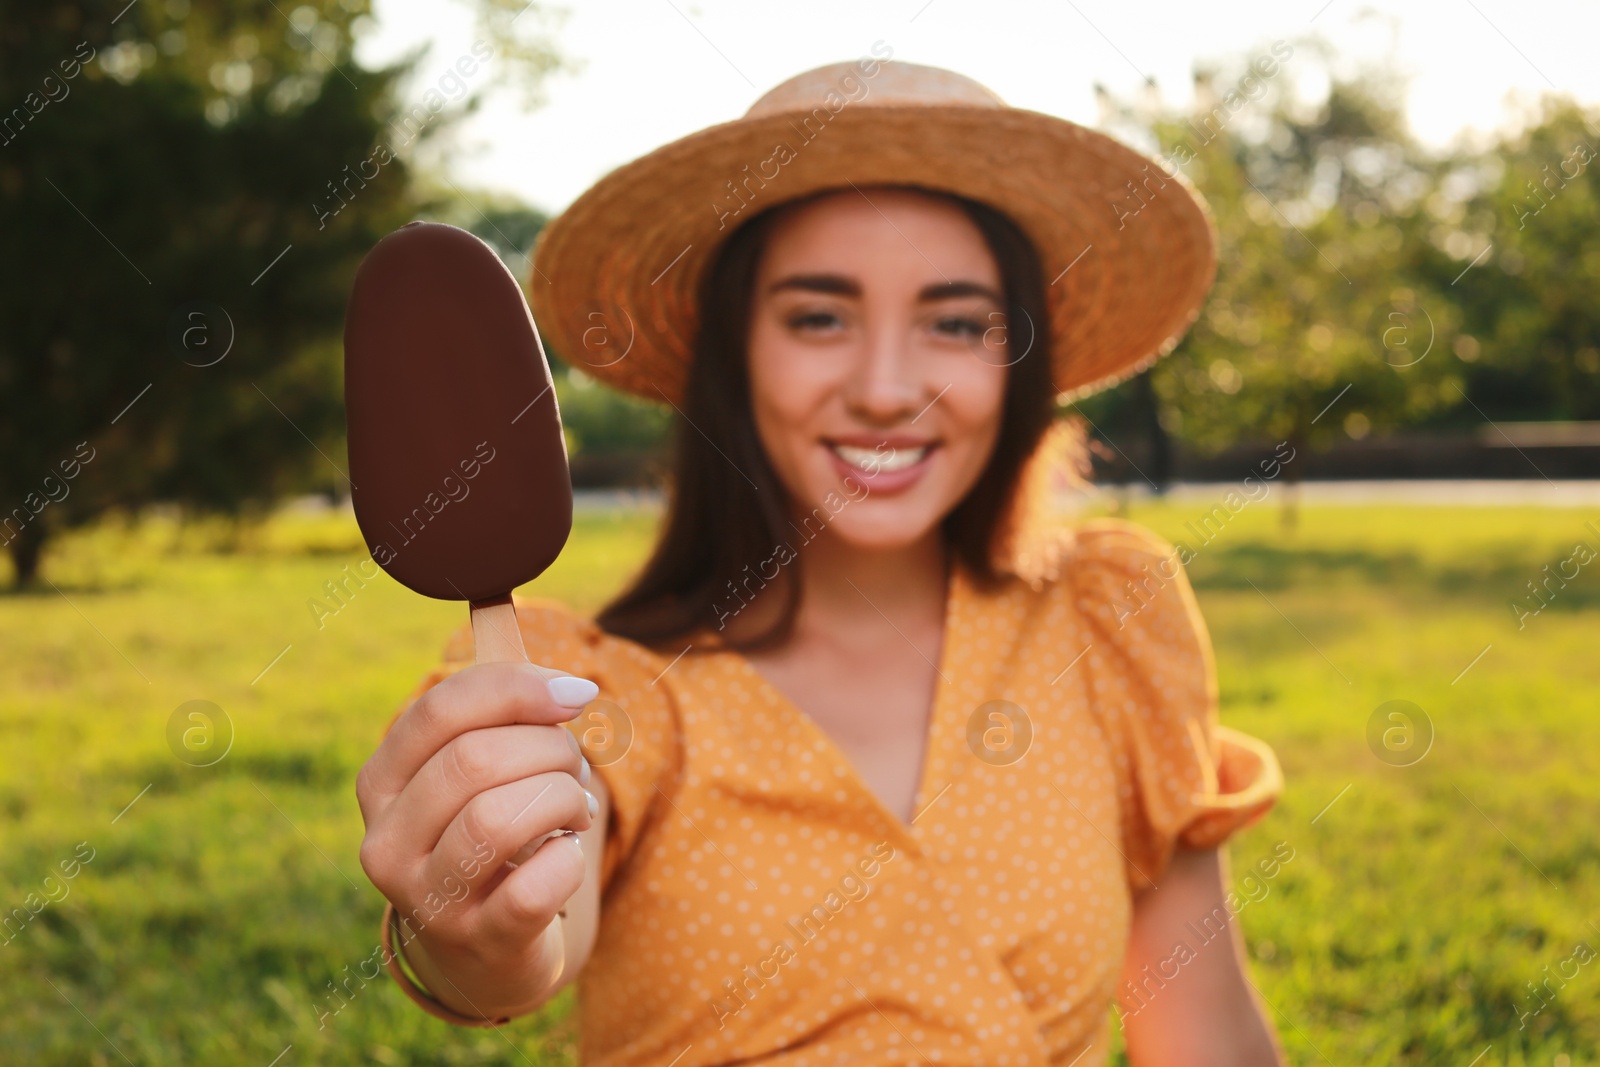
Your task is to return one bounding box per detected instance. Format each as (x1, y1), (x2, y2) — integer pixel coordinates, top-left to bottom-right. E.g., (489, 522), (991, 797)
(355, 662), (598, 1017)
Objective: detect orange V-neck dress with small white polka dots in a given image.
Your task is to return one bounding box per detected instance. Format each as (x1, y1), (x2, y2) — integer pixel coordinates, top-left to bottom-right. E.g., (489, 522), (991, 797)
(403, 520), (1282, 1067)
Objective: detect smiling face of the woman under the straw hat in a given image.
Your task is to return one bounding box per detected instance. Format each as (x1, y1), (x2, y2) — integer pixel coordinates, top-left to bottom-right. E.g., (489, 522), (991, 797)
(749, 187), (1010, 549)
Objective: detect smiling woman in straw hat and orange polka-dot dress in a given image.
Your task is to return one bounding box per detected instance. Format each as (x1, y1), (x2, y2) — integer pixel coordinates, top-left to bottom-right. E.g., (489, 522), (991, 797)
(357, 59), (1282, 1067)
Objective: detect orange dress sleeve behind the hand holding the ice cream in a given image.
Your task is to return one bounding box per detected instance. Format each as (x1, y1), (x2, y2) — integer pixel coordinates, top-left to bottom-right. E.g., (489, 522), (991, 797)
(390, 597), (683, 893)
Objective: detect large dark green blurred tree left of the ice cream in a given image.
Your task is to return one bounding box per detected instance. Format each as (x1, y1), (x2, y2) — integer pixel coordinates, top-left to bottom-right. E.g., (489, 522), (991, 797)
(0, 0), (572, 584)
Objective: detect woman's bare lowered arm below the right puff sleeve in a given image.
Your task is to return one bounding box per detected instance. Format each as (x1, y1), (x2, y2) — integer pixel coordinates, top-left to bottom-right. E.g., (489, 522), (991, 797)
(1117, 849), (1282, 1067)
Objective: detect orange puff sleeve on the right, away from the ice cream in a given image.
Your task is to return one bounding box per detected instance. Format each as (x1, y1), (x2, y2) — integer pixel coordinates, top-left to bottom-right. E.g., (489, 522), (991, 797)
(1064, 520), (1283, 891)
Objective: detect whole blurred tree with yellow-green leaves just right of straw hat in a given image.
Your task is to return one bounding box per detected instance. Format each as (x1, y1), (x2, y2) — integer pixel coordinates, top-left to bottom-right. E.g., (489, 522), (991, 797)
(1081, 42), (1461, 515)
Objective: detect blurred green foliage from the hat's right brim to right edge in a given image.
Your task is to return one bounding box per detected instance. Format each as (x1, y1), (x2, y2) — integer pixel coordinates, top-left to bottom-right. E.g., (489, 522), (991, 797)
(1082, 42), (1600, 467)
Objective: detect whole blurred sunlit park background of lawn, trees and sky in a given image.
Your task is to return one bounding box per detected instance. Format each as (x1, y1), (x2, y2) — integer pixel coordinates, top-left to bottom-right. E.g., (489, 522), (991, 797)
(0, 0), (1600, 1067)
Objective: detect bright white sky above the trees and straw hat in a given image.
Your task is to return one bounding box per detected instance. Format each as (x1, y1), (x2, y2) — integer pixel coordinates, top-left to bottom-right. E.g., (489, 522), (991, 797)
(357, 0), (1600, 213)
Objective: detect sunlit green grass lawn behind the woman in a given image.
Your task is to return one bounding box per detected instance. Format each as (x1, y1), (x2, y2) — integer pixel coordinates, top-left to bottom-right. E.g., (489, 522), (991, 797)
(0, 494), (1600, 1067)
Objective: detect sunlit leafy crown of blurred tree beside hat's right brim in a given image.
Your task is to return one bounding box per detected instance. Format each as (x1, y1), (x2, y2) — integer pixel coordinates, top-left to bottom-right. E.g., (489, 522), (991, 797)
(1154, 86), (1453, 448)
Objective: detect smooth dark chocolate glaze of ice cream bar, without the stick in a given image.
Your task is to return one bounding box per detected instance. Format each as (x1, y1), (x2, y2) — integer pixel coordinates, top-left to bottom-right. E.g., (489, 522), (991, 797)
(344, 222), (573, 601)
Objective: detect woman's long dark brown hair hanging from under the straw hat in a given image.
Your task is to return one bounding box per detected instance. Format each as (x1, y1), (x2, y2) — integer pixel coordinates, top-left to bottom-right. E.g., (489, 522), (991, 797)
(595, 189), (1056, 649)
